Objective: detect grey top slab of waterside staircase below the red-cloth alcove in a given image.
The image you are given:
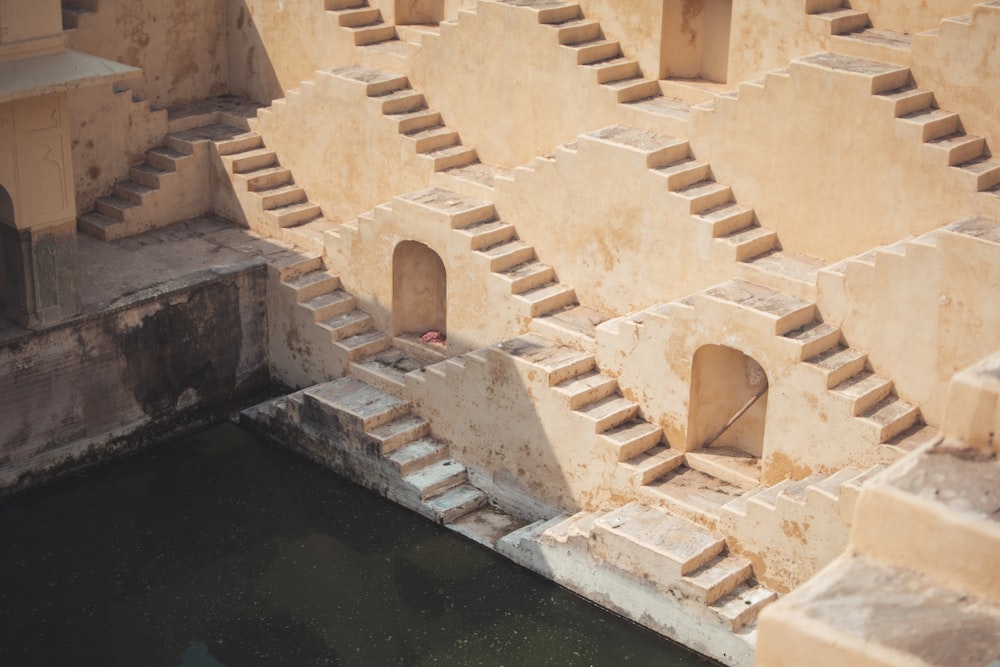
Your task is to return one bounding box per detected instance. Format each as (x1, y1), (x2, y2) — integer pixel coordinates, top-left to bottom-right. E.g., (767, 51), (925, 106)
(303, 377), (410, 431)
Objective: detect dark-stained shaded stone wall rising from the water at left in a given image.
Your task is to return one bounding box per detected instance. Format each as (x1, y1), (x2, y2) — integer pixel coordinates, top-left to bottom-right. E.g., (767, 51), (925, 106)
(0, 263), (268, 493)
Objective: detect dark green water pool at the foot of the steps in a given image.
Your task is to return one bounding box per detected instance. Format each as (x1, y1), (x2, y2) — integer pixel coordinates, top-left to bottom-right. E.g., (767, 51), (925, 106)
(0, 424), (714, 667)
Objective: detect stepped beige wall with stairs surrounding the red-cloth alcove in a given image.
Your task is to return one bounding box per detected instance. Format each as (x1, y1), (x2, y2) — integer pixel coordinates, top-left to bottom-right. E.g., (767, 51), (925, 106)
(327, 189), (576, 354)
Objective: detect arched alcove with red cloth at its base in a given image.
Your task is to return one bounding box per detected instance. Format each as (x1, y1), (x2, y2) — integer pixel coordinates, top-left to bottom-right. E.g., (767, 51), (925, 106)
(392, 241), (448, 336)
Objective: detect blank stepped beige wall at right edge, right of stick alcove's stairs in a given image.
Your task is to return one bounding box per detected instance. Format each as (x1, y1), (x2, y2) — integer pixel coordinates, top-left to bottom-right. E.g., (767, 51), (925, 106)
(819, 218), (1000, 424)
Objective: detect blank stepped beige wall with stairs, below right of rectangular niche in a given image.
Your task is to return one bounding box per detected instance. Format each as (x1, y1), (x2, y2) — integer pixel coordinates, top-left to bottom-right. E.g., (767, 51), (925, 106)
(692, 54), (1000, 261)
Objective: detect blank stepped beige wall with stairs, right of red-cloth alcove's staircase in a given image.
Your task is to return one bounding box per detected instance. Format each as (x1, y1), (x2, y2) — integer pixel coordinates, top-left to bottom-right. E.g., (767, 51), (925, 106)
(496, 126), (818, 315)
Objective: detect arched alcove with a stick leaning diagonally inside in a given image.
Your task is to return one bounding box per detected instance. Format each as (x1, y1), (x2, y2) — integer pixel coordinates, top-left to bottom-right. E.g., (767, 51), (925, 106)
(687, 345), (768, 458)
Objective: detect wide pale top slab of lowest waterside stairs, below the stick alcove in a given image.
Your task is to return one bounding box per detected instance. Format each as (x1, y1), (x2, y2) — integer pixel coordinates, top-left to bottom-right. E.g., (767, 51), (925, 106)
(591, 502), (725, 584)
